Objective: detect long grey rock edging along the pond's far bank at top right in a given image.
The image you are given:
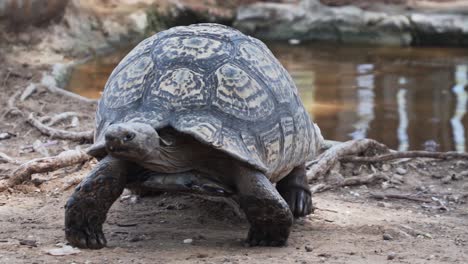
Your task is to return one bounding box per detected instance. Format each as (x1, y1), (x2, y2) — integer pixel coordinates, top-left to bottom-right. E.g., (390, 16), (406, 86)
(234, 0), (468, 46)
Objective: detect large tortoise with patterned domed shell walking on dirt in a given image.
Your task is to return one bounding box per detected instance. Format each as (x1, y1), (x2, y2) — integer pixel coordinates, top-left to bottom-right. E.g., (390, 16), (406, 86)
(65, 23), (323, 249)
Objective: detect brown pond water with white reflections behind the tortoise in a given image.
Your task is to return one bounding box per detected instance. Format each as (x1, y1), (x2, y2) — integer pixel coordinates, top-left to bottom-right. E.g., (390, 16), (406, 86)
(68, 43), (468, 151)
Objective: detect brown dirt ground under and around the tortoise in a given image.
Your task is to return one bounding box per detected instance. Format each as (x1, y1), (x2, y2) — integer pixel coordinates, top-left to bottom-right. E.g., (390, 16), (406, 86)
(0, 0), (468, 264)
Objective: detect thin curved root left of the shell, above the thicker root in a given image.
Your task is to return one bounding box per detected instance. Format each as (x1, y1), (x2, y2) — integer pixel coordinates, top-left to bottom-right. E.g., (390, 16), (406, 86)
(27, 113), (94, 142)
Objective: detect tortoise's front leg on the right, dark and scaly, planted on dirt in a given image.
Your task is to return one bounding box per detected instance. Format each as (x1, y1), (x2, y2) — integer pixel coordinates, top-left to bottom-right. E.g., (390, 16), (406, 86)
(235, 168), (293, 246)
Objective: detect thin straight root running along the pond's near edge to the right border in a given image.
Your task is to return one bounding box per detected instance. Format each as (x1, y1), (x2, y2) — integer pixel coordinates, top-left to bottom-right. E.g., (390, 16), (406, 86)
(340, 151), (468, 163)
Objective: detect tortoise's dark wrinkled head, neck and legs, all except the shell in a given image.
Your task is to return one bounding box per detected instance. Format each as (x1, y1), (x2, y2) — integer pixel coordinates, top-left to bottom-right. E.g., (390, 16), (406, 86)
(65, 124), (312, 249)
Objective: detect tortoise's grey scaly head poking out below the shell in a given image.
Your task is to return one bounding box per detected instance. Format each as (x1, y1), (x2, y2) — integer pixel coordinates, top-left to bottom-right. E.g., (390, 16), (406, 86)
(104, 123), (160, 161)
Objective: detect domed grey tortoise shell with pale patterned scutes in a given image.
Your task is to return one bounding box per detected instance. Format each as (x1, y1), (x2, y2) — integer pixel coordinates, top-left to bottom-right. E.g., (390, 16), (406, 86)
(95, 24), (321, 180)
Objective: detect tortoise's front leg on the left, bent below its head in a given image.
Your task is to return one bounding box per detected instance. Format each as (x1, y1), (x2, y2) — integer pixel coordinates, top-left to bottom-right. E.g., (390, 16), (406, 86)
(65, 156), (128, 249)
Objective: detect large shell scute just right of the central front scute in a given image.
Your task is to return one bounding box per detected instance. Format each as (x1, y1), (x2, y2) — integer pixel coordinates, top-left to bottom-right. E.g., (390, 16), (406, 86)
(213, 64), (274, 120)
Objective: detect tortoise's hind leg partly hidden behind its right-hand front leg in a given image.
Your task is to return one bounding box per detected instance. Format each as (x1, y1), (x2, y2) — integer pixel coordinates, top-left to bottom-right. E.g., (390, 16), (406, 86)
(276, 165), (313, 217)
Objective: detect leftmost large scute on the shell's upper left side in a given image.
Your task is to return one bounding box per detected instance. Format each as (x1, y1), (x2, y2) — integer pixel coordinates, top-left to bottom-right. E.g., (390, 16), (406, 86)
(103, 56), (153, 108)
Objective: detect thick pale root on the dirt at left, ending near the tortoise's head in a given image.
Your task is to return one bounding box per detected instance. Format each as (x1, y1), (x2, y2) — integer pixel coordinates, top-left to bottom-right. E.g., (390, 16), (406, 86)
(0, 150), (92, 191)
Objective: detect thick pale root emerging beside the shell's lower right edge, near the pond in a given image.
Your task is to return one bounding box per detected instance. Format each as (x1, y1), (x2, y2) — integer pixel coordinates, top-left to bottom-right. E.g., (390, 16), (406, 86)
(306, 139), (389, 182)
